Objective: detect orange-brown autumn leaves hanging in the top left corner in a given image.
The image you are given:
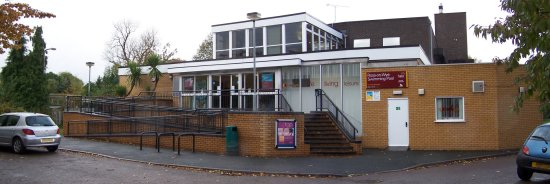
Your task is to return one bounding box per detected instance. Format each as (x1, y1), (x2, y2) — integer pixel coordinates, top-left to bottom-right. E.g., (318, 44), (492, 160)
(0, 3), (55, 54)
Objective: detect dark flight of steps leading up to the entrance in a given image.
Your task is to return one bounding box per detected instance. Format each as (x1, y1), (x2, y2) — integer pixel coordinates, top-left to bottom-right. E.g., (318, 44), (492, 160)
(305, 112), (356, 155)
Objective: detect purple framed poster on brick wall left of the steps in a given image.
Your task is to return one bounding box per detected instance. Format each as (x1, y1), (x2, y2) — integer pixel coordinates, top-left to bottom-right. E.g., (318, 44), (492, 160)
(275, 119), (296, 149)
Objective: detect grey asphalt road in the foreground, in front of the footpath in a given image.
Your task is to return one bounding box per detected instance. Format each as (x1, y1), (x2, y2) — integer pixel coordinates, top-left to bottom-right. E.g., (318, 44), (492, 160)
(0, 148), (550, 184)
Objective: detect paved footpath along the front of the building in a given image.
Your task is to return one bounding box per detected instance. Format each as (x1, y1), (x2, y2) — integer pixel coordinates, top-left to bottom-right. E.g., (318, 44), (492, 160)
(60, 137), (516, 176)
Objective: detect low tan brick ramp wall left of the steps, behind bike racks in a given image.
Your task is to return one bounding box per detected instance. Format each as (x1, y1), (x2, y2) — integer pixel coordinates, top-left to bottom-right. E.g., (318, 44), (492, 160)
(63, 112), (310, 157)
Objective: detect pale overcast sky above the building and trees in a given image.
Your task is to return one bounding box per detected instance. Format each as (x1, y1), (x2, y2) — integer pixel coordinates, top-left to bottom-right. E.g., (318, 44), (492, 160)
(0, 0), (513, 83)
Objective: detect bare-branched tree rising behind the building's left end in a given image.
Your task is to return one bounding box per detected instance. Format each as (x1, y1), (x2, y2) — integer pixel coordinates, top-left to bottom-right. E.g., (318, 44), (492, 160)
(105, 20), (177, 66)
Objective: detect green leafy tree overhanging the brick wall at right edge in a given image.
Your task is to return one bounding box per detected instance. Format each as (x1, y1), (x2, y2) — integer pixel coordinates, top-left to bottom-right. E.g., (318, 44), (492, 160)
(474, 0), (550, 112)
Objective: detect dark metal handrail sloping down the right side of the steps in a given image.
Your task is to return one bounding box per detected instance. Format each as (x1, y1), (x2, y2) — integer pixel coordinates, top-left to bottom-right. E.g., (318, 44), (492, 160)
(315, 89), (359, 141)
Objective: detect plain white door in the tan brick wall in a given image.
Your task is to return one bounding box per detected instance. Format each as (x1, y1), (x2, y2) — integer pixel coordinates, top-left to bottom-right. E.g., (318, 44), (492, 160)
(388, 98), (409, 150)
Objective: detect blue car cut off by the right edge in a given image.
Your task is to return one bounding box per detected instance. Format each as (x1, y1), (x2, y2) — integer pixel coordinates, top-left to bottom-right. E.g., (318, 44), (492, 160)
(516, 123), (550, 181)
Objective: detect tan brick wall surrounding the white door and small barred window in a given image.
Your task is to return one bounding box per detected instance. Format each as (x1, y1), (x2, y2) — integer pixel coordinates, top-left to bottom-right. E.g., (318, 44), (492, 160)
(361, 63), (543, 150)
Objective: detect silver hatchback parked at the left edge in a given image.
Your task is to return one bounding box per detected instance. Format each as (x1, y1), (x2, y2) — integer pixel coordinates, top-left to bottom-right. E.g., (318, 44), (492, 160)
(0, 112), (61, 153)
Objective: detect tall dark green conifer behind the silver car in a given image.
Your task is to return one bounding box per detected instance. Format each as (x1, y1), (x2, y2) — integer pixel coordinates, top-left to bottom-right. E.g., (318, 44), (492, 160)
(1, 27), (49, 112)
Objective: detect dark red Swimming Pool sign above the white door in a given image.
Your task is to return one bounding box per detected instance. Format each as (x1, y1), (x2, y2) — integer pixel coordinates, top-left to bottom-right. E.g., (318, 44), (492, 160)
(367, 71), (409, 89)
